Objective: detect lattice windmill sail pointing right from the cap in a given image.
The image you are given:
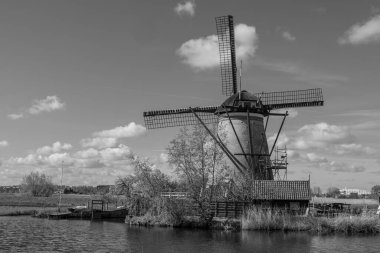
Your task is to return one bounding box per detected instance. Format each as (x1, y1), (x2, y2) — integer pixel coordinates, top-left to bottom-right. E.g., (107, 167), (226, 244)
(255, 88), (323, 110)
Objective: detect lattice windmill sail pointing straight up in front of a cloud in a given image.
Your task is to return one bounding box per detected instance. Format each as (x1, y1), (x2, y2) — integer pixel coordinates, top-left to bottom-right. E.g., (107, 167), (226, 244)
(215, 16), (237, 96)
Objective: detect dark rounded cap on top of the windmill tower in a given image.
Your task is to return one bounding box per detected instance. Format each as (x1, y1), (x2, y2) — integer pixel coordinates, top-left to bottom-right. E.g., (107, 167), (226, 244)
(216, 90), (262, 113)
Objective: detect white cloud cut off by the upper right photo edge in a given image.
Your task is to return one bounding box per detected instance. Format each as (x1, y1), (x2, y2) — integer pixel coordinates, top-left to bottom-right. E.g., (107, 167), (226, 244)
(338, 15), (380, 45)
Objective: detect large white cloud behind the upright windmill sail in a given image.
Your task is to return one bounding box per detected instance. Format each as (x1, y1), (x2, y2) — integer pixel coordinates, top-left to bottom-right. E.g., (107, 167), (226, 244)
(176, 24), (258, 70)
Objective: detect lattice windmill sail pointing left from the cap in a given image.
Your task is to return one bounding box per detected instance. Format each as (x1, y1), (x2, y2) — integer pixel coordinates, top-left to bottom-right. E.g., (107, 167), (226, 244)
(144, 106), (218, 129)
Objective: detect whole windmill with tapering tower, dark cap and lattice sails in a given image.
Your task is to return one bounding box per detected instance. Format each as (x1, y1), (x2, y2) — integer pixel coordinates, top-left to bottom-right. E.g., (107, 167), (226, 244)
(144, 16), (323, 188)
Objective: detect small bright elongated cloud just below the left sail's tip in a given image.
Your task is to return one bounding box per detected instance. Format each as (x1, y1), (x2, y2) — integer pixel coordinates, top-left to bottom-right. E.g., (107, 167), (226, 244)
(94, 122), (146, 138)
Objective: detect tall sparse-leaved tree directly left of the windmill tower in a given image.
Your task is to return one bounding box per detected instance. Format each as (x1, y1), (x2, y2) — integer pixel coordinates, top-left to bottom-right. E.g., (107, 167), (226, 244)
(167, 125), (228, 219)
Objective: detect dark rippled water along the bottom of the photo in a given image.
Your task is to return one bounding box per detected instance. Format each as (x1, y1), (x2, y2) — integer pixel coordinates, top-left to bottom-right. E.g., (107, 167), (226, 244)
(0, 217), (380, 253)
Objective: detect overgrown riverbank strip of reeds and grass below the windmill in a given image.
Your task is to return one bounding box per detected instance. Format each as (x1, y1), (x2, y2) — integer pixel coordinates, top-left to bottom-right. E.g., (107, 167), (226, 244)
(125, 210), (380, 234)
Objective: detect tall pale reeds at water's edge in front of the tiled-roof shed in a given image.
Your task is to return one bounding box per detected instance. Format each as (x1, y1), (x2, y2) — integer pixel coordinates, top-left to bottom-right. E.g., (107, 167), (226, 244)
(241, 208), (380, 234)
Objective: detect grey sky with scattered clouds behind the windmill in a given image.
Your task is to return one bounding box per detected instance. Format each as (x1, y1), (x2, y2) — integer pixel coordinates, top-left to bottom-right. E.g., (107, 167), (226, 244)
(0, 0), (380, 190)
